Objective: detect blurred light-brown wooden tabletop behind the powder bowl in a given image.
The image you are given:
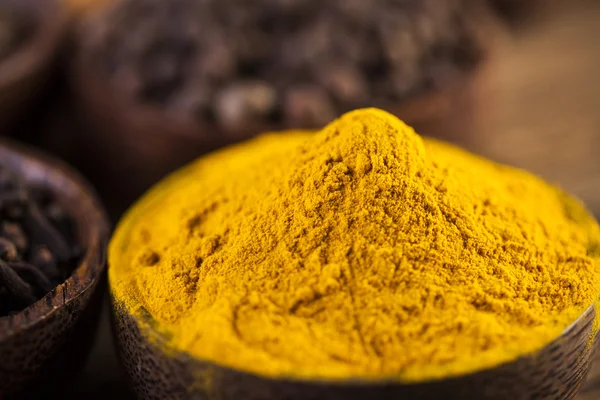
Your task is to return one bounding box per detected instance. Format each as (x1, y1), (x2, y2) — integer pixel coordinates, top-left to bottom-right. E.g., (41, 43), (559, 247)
(10, 0), (600, 400)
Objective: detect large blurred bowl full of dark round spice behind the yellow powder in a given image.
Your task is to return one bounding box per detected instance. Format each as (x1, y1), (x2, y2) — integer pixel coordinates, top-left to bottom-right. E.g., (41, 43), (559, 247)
(70, 0), (502, 219)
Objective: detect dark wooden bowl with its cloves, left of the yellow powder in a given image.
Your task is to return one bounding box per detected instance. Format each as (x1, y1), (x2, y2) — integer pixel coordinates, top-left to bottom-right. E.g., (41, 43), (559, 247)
(0, 141), (109, 399)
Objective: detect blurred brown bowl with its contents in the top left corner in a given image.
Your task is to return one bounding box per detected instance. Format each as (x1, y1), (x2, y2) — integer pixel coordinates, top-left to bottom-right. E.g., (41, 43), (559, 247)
(0, 0), (67, 128)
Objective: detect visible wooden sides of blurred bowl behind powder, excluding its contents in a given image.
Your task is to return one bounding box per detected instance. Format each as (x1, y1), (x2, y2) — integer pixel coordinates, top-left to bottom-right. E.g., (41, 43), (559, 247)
(69, 54), (482, 220)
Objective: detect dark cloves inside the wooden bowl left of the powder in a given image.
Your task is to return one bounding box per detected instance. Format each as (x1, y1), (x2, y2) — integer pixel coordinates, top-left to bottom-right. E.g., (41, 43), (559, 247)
(0, 164), (81, 318)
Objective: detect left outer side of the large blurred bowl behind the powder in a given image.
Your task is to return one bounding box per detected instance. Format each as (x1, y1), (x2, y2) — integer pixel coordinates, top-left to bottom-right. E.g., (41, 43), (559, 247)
(69, 48), (260, 218)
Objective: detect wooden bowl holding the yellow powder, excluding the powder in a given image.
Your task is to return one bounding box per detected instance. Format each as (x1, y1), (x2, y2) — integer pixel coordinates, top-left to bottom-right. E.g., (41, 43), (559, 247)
(113, 298), (597, 400)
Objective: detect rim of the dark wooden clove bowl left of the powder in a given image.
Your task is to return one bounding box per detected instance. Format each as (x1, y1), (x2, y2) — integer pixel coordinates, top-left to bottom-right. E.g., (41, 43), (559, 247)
(0, 139), (109, 342)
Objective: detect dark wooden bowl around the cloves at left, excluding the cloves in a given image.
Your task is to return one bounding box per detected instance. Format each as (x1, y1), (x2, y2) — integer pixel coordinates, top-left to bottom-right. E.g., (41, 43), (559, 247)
(0, 141), (109, 399)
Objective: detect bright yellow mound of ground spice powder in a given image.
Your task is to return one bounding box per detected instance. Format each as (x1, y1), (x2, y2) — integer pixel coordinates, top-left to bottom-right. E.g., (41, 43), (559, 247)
(109, 109), (600, 381)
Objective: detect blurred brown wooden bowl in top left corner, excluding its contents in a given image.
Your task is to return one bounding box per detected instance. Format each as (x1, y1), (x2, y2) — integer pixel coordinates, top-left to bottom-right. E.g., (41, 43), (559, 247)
(0, 0), (67, 129)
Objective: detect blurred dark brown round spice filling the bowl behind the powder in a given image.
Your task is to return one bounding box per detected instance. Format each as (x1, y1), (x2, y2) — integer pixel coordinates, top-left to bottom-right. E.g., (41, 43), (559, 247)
(81, 0), (490, 131)
